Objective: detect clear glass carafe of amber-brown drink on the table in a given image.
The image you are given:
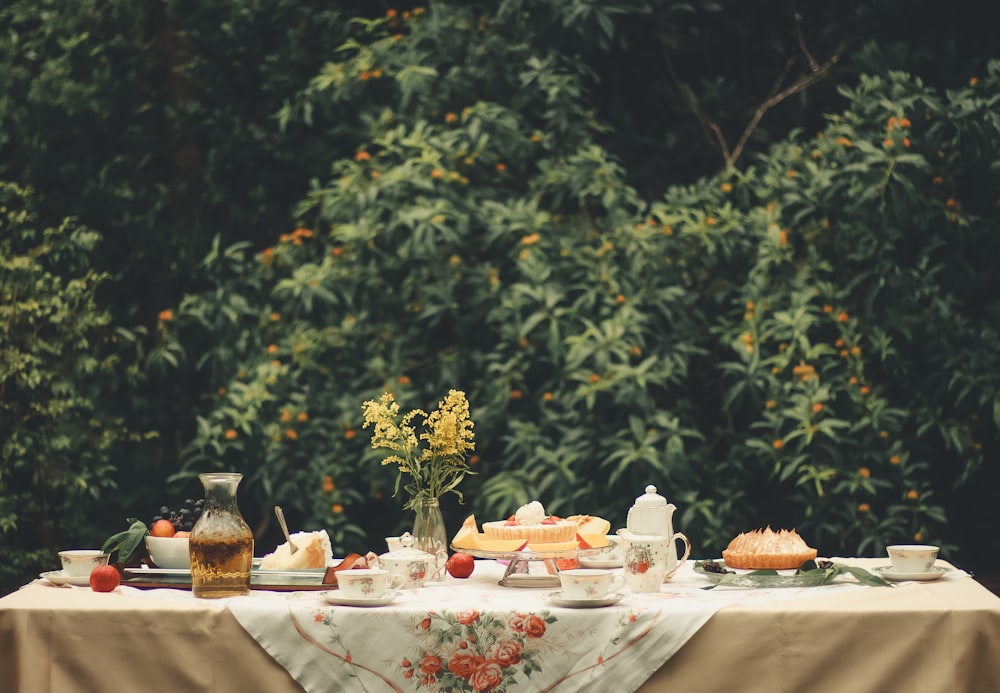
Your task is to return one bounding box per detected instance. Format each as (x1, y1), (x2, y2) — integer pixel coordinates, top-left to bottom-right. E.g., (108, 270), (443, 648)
(190, 472), (253, 599)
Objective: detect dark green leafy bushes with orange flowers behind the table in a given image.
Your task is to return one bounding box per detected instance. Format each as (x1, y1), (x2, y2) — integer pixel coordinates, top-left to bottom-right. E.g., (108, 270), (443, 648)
(0, 0), (1000, 589)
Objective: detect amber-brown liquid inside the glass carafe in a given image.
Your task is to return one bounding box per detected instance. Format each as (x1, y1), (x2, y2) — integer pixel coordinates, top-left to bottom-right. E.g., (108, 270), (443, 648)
(190, 535), (253, 598)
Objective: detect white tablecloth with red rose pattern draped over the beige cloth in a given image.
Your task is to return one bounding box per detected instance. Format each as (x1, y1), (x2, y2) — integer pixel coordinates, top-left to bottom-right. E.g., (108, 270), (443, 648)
(223, 561), (865, 693)
